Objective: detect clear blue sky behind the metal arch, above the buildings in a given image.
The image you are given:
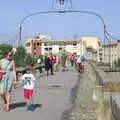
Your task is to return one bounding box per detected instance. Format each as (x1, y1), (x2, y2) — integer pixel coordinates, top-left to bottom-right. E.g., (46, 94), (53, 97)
(0, 0), (120, 44)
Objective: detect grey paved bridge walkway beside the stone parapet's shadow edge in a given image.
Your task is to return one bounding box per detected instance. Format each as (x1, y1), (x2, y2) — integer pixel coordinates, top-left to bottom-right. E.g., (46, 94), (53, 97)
(0, 68), (78, 120)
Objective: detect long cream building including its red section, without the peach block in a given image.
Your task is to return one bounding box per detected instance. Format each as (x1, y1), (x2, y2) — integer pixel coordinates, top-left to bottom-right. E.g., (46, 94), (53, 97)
(25, 35), (86, 55)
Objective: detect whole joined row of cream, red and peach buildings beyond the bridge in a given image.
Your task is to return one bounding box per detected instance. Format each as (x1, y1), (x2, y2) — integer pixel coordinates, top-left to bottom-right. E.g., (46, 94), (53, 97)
(25, 35), (100, 60)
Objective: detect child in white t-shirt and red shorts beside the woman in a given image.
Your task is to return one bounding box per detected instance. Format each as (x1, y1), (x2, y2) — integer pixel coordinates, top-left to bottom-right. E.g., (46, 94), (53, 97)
(21, 66), (36, 111)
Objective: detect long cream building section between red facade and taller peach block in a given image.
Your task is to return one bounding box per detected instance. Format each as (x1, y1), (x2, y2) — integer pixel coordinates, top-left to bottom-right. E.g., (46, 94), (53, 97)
(42, 40), (86, 55)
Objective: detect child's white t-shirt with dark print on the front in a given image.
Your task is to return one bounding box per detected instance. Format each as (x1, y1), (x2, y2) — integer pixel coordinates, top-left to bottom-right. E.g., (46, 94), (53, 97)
(21, 73), (35, 90)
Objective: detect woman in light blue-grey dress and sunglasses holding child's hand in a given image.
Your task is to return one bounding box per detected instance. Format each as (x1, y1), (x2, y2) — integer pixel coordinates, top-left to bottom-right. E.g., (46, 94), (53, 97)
(0, 51), (17, 112)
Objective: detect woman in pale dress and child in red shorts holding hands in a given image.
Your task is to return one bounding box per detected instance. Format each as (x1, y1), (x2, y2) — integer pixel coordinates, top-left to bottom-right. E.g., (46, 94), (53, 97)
(0, 51), (36, 112)
